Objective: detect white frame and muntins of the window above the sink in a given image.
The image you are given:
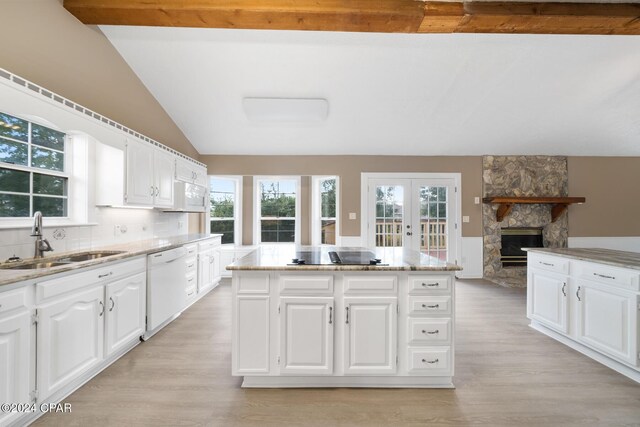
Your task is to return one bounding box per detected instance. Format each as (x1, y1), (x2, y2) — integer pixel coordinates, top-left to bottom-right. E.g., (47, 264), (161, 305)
(0, 111), (75, 229)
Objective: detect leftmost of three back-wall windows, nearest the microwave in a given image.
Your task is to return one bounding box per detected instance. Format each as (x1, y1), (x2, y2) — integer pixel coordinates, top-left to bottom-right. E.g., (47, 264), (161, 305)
(209, 176), (242, 245)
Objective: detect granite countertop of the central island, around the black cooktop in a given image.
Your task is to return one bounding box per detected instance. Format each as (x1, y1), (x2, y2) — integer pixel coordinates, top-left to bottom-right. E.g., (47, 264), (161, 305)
(226, 244), (462, 271)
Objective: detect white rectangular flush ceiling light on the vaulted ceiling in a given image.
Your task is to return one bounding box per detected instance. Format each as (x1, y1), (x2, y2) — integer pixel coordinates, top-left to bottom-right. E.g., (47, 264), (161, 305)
(242, 97), (329, 123)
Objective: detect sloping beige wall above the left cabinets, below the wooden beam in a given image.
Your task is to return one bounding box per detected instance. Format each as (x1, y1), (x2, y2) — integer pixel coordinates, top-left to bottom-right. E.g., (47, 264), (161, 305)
(0, 0), (198, 159)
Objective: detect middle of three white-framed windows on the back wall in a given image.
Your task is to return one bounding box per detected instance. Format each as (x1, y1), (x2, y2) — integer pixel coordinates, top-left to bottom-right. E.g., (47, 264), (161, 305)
(254, 177), (300, 243)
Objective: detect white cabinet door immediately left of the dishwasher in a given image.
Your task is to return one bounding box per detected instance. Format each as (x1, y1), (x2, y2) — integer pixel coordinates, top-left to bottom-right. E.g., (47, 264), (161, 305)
(105, 273), (147, 356)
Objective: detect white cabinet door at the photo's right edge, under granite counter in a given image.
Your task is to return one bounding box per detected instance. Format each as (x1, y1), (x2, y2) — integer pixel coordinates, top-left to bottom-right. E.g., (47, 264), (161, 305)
(575, 281), (638, 366)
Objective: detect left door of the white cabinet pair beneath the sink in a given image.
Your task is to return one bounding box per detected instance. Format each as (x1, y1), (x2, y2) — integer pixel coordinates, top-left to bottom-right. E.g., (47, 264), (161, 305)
(37, 286), (105, 400)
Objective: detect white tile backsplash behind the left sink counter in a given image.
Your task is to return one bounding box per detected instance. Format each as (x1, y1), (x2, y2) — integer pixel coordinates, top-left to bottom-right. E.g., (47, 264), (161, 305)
(0, 207), (189, 261)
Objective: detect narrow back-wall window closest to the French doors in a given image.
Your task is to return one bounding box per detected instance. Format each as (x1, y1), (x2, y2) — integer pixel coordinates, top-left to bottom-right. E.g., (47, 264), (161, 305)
(312, 176), (339, 245)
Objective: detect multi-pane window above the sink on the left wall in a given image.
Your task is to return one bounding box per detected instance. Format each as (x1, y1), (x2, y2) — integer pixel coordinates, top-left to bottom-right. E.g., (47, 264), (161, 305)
(0, 112), (69, 218)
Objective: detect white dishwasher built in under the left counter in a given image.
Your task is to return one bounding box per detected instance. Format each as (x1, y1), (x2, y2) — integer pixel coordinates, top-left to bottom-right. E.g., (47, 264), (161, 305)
(144, 247), (187, 339)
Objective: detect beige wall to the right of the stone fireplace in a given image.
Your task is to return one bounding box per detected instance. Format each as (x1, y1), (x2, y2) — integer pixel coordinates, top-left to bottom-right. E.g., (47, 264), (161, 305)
(568, 157), (640, 237)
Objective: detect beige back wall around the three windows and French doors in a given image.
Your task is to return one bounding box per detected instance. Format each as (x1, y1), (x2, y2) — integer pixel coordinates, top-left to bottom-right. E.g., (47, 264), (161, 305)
(200, 156), (482, 244)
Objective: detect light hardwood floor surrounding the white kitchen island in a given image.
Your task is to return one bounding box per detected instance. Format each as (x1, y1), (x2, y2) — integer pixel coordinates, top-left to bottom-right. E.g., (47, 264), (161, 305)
(35, 280), (640, 427)
